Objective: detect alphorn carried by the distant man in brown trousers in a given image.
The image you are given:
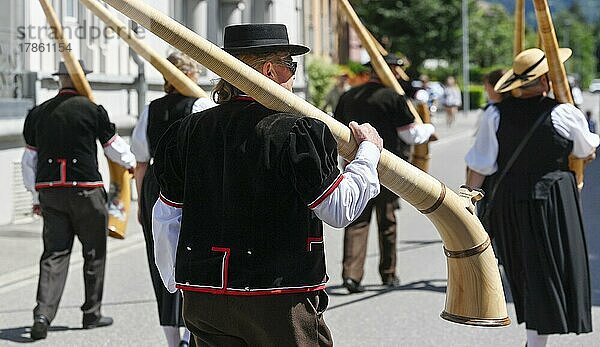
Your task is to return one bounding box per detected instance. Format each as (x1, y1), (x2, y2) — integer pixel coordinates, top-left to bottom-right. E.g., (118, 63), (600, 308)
(338, 0), (431, 172)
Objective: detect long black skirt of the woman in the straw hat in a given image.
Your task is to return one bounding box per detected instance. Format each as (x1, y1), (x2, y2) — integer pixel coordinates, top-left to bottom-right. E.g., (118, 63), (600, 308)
(490, 171), (592, 334)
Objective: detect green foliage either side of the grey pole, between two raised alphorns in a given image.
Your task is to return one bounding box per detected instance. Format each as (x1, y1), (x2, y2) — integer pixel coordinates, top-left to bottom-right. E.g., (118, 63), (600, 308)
(352, 0), (513, 74)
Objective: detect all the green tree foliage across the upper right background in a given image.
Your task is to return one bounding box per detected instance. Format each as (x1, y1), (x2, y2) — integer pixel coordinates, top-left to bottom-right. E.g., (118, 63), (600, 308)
(351, 0), (600, 87)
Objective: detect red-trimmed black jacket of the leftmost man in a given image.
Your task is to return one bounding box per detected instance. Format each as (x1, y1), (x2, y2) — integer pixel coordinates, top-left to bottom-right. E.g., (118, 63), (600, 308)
(23, 89), (116, 189)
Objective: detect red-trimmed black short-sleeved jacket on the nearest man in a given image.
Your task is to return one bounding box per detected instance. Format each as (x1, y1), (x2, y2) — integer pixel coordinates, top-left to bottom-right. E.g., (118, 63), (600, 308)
(154, 99), (340, 295)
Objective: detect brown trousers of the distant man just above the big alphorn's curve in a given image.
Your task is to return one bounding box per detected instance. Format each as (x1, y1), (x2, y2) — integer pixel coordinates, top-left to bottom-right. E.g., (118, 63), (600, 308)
(342, 187), (399, 282)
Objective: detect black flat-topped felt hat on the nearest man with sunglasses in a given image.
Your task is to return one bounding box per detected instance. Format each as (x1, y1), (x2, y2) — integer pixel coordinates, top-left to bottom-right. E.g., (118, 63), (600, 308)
(223, 24), (310, 55)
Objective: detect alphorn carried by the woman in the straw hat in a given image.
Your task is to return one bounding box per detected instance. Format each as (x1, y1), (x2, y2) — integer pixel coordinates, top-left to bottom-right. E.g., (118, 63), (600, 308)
(533, 0), (585, 191)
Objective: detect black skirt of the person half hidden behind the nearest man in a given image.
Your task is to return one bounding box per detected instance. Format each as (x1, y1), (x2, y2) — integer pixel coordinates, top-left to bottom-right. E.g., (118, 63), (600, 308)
(138, 165), (184, 326)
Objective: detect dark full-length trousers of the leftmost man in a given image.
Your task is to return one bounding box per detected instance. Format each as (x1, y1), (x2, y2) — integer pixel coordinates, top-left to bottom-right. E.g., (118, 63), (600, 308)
(33, 188), (108, 321)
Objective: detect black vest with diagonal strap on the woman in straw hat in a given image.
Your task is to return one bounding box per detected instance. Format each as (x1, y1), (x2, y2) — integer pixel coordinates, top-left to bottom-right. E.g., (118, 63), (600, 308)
(496, 96), (573, 177)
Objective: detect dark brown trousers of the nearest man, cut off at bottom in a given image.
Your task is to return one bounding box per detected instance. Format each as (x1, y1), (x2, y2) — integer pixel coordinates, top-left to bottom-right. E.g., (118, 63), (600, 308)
(183, 291), (333, 347)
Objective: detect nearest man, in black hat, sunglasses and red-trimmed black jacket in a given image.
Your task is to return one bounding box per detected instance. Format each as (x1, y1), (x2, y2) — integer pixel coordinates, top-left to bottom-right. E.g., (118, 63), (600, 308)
(153, 24), (383, 346)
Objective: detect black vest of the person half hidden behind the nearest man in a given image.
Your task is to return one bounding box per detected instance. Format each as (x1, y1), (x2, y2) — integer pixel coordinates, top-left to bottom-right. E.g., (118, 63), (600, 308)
(146, 93), (198, 157)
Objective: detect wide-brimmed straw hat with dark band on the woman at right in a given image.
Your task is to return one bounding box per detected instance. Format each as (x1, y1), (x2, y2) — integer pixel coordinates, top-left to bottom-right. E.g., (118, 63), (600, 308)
(494, 48), (573, 93)
